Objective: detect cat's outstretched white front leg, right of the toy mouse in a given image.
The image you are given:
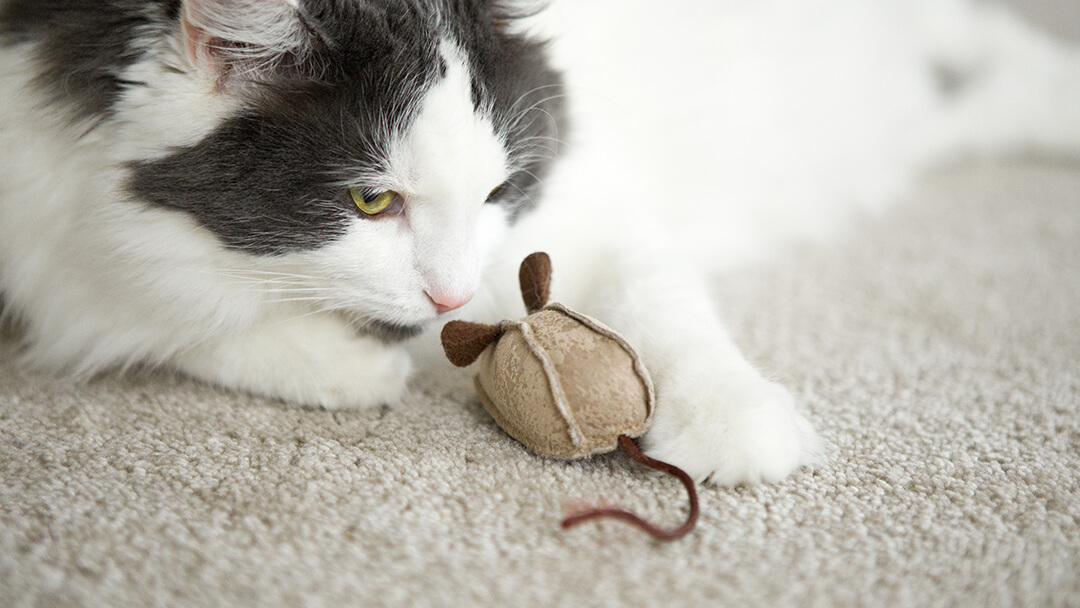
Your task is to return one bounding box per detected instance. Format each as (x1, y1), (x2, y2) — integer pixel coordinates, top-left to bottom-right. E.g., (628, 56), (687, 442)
(535, 235), (819, 485)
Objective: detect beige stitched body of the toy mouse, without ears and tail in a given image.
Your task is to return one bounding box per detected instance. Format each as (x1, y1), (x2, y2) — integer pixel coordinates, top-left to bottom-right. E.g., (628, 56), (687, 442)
(476, 303), (656, 459)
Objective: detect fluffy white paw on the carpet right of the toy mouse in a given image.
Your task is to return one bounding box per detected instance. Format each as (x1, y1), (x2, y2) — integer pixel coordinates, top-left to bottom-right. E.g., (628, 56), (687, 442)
(644, 373), (820, 486)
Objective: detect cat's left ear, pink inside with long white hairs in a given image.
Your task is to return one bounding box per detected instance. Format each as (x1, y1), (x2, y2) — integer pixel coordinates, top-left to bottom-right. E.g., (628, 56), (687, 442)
(180, 0), (309, 87)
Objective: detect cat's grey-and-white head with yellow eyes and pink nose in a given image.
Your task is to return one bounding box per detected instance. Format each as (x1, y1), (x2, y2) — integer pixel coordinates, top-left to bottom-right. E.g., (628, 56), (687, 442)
(130, 0), (562, 337)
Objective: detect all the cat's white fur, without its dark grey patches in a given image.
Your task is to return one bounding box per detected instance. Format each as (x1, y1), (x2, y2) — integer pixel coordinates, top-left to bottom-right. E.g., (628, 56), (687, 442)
(0, 0), (1080, 484)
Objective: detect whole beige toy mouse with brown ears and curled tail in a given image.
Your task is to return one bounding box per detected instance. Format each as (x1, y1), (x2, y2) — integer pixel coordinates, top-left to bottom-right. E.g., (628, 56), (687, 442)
(442, 253), (698, 540)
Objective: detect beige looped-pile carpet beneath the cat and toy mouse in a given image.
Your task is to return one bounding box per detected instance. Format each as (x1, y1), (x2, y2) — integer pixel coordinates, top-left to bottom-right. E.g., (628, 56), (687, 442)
(0, 11), (1080, 607)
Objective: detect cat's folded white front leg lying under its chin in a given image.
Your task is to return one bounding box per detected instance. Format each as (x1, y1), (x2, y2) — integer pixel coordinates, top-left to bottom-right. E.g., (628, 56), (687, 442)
(175, 315), (411, 409)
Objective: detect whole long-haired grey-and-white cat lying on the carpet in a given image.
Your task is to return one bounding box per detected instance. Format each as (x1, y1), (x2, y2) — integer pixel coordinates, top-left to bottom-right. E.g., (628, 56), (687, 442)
(0, 0), (1080, 485)
